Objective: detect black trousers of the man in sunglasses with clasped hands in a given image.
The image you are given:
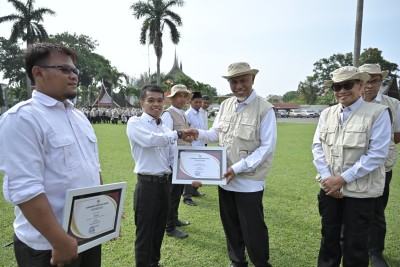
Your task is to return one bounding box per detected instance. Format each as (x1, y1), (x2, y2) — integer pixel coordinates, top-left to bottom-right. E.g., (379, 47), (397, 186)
(318, 189), (375, 267)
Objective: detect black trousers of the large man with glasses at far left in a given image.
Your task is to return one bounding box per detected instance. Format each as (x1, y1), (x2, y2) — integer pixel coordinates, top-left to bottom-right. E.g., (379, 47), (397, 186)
(14, 235), (101, 267)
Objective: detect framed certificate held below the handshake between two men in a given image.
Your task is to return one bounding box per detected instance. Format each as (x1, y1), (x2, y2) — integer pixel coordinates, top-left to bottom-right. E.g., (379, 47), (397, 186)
(172, 146), (226, 185)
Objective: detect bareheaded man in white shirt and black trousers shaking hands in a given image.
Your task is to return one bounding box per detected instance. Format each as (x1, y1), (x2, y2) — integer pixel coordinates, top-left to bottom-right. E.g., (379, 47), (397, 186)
(126, 85), (193, 266)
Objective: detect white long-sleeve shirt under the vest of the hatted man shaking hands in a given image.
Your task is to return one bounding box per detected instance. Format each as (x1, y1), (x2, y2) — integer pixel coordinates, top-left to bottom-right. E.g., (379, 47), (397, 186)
(198, 90), (277, 192)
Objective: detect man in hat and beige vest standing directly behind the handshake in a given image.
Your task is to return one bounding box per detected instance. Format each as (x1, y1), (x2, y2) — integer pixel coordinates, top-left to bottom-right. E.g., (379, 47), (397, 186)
(161, 84), (192, 238)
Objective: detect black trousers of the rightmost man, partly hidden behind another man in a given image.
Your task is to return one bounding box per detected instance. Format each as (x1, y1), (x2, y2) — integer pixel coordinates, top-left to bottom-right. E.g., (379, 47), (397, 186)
(368, 171), (392, 254)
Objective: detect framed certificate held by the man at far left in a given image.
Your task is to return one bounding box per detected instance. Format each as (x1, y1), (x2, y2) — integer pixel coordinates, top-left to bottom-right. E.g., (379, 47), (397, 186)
(63, 182), (126, 253)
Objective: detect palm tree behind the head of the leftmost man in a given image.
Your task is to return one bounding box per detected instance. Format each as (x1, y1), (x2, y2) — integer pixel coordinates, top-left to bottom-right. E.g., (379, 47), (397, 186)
(0, 0), (56, 97)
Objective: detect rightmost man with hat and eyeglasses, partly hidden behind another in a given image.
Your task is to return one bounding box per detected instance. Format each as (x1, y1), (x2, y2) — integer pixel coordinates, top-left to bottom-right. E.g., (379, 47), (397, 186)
(359, 64), (400, 267)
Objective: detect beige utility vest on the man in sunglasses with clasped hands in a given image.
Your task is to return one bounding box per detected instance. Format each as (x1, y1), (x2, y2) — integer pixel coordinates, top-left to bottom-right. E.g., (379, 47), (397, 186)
(319, 102), (387, 198)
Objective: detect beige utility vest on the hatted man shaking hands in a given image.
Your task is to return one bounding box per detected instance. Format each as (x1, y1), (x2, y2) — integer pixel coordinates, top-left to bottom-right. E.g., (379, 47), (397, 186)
(218, 96), (273, 181)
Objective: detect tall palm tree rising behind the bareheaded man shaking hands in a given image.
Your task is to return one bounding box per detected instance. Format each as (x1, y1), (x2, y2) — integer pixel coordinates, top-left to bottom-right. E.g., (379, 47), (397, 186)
(131, 0), (184, 85)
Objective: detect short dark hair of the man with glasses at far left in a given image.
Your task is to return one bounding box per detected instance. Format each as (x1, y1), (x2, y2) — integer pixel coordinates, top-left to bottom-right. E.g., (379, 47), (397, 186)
(24, 43), (78, 82)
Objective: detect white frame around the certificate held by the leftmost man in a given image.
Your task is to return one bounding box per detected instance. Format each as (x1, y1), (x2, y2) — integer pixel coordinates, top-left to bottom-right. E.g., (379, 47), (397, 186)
(63, 182), (126, 253)
